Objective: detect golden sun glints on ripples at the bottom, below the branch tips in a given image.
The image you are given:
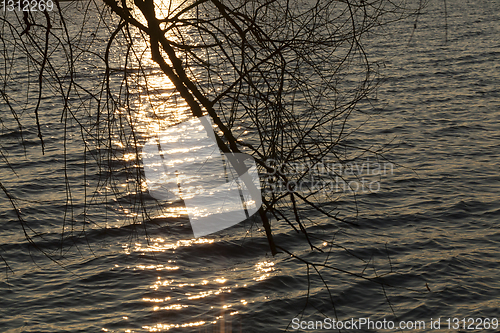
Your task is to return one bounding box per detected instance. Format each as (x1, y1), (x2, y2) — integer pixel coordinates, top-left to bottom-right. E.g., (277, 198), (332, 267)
(120, 237), (275, 332)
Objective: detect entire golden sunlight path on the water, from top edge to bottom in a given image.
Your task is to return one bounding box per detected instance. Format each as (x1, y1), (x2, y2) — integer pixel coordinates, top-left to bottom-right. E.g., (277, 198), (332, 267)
(107, 1), (275, 332)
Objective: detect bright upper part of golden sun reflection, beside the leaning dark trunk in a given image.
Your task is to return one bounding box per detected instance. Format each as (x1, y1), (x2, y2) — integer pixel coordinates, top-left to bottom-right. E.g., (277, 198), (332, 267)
(111, 0), (201, 222)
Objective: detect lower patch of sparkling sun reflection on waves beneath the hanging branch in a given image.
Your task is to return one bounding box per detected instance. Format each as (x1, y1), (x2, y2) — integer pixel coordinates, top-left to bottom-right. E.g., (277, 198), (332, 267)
(119, 232), (274, 332)
